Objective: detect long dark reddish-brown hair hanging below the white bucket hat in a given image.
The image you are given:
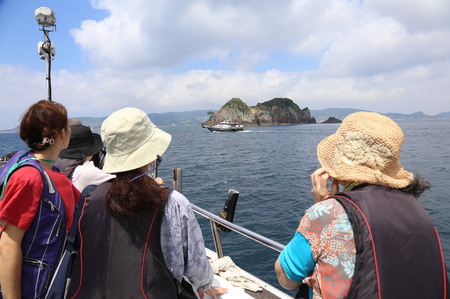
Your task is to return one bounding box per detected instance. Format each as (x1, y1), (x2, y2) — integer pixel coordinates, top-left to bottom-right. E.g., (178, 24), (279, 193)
(105, 169), (169, 215)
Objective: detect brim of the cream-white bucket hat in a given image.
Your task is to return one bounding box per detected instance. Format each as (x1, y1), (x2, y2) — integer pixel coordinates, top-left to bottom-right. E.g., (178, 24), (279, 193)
(103, 128), (172, 173)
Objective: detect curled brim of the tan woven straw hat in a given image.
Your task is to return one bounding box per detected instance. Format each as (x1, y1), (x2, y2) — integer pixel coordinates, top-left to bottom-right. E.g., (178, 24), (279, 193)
(317, 134), (413, 188)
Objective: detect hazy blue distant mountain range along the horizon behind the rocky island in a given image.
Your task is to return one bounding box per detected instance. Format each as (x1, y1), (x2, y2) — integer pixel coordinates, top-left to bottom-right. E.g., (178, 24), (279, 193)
(0, 108), (450, 133)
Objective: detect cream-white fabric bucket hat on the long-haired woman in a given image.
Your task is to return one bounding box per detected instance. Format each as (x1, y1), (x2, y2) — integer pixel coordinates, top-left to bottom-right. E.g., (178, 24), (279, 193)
(101, 108), (172, 173)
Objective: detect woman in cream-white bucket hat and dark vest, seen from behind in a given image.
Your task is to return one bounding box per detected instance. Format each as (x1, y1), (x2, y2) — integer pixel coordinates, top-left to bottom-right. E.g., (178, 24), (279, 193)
(68, 108), (224, 298)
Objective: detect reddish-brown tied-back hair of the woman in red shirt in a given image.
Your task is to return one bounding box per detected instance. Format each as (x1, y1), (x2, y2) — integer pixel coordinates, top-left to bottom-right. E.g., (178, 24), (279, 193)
(20, 100), (68, 150)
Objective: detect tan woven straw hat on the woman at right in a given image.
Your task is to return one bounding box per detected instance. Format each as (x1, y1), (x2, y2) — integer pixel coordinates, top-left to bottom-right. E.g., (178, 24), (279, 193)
(317, 112), (413, 188)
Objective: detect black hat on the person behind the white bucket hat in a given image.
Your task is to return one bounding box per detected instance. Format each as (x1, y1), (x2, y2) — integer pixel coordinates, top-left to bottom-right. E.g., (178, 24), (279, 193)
(59, 124), (103, 160)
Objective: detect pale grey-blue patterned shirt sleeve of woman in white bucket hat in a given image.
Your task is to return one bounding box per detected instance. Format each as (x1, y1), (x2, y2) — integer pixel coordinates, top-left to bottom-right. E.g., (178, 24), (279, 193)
(161, 190), (214, 290)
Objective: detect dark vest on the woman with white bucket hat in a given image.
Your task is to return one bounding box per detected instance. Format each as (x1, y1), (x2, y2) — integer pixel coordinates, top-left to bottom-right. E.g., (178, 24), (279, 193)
(67, 182), (176, 299)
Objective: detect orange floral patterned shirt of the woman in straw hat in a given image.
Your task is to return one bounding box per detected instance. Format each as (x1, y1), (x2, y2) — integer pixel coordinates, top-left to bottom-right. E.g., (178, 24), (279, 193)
(297, 198), (356, 299)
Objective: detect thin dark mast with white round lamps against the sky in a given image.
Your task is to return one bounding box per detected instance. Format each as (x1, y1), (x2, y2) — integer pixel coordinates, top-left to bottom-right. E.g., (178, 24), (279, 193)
(34, 7), (56, 101)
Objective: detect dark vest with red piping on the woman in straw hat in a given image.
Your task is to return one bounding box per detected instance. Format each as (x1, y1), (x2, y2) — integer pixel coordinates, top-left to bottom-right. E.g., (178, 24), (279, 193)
(333, 185), (449, 299)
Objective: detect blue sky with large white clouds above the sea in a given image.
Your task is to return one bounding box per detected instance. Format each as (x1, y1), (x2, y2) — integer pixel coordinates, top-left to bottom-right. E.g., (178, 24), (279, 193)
(0, 0), (450, 129)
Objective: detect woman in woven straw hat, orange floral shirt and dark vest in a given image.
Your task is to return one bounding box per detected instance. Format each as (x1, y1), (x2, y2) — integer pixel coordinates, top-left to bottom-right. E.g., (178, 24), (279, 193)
(275, 112), (449, 298)
